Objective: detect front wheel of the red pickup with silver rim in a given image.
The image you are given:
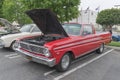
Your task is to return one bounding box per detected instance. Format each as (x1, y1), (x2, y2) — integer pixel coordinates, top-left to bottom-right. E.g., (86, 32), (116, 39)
(55, 53), (71, 72)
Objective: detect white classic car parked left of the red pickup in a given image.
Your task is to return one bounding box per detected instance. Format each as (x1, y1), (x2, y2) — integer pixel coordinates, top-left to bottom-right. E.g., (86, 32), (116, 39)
(0, 24), (41, 50)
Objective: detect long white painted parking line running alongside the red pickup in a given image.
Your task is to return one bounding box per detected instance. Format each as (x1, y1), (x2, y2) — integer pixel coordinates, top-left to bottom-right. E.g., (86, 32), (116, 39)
(53, 49), (114, 80)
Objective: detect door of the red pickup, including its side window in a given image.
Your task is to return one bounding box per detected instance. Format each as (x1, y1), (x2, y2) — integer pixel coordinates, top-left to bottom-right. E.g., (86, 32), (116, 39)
(81, 25), (97, 53)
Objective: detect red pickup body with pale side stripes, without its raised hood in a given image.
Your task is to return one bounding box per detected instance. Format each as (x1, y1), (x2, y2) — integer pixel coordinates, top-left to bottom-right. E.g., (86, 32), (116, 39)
(16, 9), (111, 71)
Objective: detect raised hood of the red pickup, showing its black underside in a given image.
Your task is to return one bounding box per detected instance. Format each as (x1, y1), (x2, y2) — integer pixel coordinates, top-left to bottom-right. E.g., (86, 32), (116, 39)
(26, 9), (68, 37)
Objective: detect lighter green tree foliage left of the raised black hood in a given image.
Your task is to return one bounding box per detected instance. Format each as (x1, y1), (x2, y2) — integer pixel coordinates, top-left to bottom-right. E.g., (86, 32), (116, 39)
(2, 0), (31, 24)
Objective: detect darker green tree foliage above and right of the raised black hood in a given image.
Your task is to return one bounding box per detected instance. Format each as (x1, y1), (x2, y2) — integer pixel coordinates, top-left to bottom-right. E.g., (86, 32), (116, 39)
(22, 0), (80, 22)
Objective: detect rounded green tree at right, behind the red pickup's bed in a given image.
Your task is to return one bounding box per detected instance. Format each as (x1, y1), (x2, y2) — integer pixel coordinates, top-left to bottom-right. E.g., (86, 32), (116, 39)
(96, 8), (120, 30)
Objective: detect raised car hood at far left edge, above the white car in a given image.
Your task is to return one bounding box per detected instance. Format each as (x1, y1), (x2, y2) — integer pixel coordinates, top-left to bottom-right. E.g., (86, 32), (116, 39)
(0, 18), (19, 32)
